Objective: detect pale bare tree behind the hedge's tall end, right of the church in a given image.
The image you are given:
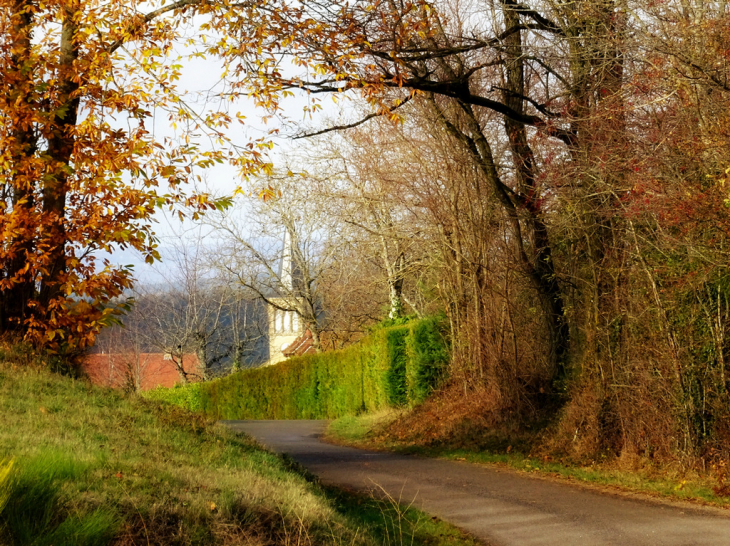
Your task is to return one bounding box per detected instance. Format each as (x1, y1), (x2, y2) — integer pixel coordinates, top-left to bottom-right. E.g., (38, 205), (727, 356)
(302, 124), (432, 319)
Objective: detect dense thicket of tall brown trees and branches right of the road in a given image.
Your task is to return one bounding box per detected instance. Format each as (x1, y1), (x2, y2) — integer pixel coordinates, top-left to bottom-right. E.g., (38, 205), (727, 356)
(249, 0), (730, 457)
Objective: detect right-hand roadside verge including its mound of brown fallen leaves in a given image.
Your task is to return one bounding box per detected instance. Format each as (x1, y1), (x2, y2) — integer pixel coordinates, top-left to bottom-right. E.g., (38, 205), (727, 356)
(327, 384), (730, 507)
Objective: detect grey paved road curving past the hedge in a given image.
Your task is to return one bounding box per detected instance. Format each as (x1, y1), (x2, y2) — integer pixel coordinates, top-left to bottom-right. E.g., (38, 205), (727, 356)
(224, 421), (730, 546)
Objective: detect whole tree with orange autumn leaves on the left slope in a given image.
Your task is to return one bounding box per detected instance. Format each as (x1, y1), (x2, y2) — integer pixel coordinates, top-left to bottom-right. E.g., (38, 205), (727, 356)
(0, 0), (292, 351)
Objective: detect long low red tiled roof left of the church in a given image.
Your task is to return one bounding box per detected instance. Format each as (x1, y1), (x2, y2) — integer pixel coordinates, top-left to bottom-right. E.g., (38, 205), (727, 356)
(81, 352), (200, 391)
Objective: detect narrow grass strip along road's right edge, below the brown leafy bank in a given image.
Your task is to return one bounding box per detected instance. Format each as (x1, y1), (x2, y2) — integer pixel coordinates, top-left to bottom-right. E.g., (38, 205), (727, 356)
(326, 411), (730, 508)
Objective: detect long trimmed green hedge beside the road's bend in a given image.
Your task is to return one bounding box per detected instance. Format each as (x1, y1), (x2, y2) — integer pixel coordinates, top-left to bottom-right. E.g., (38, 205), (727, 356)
(145, 317), (449, 419)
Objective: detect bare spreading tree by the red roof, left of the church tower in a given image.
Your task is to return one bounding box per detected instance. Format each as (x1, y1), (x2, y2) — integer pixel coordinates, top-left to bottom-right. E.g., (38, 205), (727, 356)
(103, 226), (267, 382)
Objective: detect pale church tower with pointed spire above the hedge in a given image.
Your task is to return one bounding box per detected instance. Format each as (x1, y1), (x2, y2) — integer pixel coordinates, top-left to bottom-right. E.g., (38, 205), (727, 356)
(268, 229), (304, 364)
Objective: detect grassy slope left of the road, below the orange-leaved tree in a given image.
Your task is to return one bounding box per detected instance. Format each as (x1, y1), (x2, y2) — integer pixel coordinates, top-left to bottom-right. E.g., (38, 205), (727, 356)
(0, 344), (473, 546)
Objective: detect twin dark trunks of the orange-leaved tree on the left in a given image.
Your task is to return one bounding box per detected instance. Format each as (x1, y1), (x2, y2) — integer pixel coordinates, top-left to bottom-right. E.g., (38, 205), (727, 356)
(0, 0), (79, 331)
